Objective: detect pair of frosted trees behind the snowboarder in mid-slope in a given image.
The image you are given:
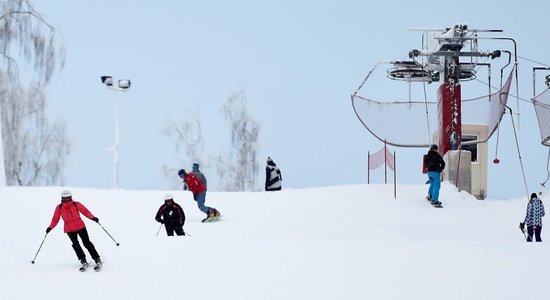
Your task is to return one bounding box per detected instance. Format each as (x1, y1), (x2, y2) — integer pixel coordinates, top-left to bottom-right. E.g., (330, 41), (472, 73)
(161, 91), (260, 191)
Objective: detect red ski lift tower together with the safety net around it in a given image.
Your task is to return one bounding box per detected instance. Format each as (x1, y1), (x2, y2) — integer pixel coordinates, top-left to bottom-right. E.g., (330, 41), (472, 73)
(352, 24), (519, 199)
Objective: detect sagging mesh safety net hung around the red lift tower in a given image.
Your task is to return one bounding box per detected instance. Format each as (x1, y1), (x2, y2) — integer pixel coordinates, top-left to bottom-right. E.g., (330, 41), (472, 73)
(351, 67), (516, 147)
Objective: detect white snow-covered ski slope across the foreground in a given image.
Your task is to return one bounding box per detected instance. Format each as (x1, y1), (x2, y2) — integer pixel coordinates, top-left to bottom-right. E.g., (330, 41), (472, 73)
(0, 183), (550, 300)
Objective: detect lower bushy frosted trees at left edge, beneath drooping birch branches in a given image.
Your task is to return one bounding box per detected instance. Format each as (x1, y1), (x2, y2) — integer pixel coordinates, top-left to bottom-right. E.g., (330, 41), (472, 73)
(0, 76), (71, 185)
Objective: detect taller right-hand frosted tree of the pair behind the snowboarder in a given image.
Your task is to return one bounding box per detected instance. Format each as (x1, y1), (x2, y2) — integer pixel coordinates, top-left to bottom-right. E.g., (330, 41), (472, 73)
(216, 90), (260, 191)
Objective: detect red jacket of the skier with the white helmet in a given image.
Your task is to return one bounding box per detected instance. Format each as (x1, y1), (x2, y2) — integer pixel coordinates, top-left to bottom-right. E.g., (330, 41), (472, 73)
(50, 200), (94, 232)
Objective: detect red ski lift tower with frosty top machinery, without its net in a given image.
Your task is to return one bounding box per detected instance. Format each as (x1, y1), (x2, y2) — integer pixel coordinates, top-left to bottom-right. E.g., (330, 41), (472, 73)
(409, 24), (502, 199)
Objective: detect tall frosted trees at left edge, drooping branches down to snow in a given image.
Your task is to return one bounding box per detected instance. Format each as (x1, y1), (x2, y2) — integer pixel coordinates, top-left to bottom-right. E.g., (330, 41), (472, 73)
(0, 0), (70, 185)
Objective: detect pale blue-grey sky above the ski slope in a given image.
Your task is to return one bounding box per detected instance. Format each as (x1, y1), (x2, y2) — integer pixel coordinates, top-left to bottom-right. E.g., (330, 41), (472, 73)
(35, 0), (550, 198)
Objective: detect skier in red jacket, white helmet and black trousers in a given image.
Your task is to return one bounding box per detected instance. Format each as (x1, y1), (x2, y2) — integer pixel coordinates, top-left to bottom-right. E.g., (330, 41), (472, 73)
(46, 190), (101, 267)
